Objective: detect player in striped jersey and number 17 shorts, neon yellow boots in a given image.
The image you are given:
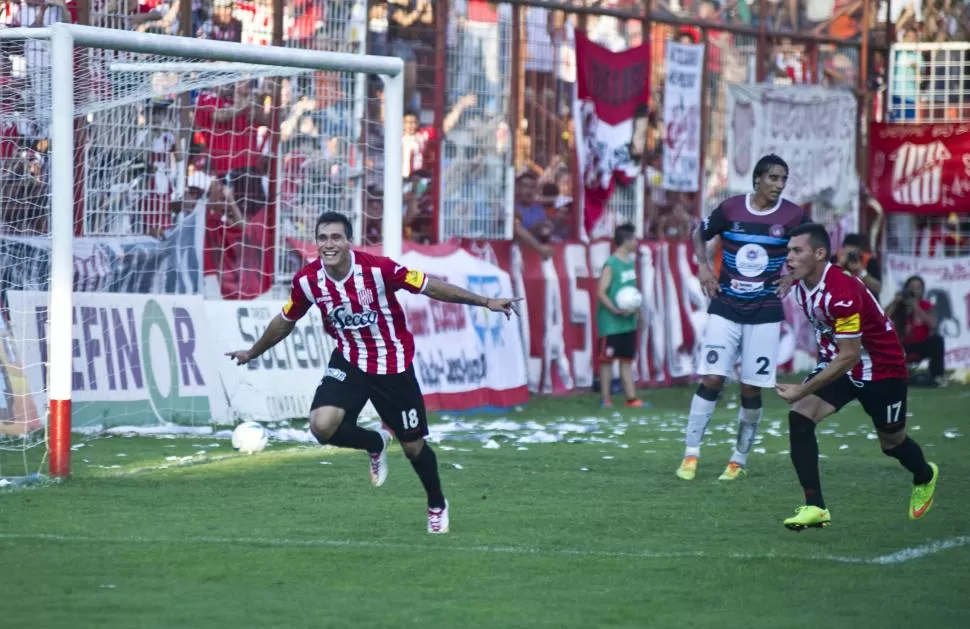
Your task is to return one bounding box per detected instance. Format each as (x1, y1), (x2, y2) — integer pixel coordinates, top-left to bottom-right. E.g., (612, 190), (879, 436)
(777, 224), (940, 531)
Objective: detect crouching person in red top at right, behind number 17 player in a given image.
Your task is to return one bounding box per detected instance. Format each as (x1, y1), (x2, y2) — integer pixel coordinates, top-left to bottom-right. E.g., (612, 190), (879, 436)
(886, 275), (944, 385)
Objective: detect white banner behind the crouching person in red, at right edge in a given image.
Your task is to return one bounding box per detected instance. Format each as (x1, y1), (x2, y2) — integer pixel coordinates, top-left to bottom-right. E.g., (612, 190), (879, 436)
(881, 254), (970, 369)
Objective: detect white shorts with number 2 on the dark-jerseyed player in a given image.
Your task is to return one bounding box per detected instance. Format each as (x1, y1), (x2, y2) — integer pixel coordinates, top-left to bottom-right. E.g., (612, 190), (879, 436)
(697, 315), (781, 389)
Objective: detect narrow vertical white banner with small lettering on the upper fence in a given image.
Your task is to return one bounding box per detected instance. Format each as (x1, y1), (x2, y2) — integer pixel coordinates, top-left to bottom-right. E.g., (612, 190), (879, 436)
(663, 41), (704, 192)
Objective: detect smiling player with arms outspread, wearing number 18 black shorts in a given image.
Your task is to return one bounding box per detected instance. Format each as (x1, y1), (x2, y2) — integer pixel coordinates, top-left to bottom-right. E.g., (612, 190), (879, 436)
(227, 212), (518, 533)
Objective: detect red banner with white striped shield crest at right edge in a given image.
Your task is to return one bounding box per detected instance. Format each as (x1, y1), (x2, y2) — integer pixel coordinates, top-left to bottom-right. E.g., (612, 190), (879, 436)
(869, 122), (970, 214)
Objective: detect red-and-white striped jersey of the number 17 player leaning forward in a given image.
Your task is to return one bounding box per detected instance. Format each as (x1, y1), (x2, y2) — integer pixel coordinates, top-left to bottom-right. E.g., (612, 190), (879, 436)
(793, 264), (907, 382)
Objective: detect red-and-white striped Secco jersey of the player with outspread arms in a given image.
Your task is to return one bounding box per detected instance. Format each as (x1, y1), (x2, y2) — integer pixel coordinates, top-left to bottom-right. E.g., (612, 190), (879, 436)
(281, 251), (428, 374)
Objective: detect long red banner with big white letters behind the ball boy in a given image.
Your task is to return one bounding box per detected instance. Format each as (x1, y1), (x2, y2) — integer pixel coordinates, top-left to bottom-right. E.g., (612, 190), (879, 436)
(465, 240), (815, 394)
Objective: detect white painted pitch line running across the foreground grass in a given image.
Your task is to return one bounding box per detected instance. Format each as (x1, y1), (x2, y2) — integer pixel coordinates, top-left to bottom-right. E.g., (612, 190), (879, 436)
(0, 533), (970, 566)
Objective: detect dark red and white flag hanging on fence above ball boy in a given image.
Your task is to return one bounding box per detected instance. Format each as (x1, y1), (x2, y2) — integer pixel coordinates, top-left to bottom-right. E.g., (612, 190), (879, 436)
(573, 31), (650, 234)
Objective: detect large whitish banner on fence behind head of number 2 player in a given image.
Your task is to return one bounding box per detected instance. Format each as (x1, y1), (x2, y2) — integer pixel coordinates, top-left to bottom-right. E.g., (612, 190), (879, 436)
(726, 84), (859, 206)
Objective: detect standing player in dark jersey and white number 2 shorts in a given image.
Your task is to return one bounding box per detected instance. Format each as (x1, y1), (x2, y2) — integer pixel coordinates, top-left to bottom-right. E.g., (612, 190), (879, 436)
(677, 155), (808, 481)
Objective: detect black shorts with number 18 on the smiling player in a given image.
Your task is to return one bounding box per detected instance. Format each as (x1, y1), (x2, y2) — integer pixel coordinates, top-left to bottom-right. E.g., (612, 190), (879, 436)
(310, 351), (428, 443)
